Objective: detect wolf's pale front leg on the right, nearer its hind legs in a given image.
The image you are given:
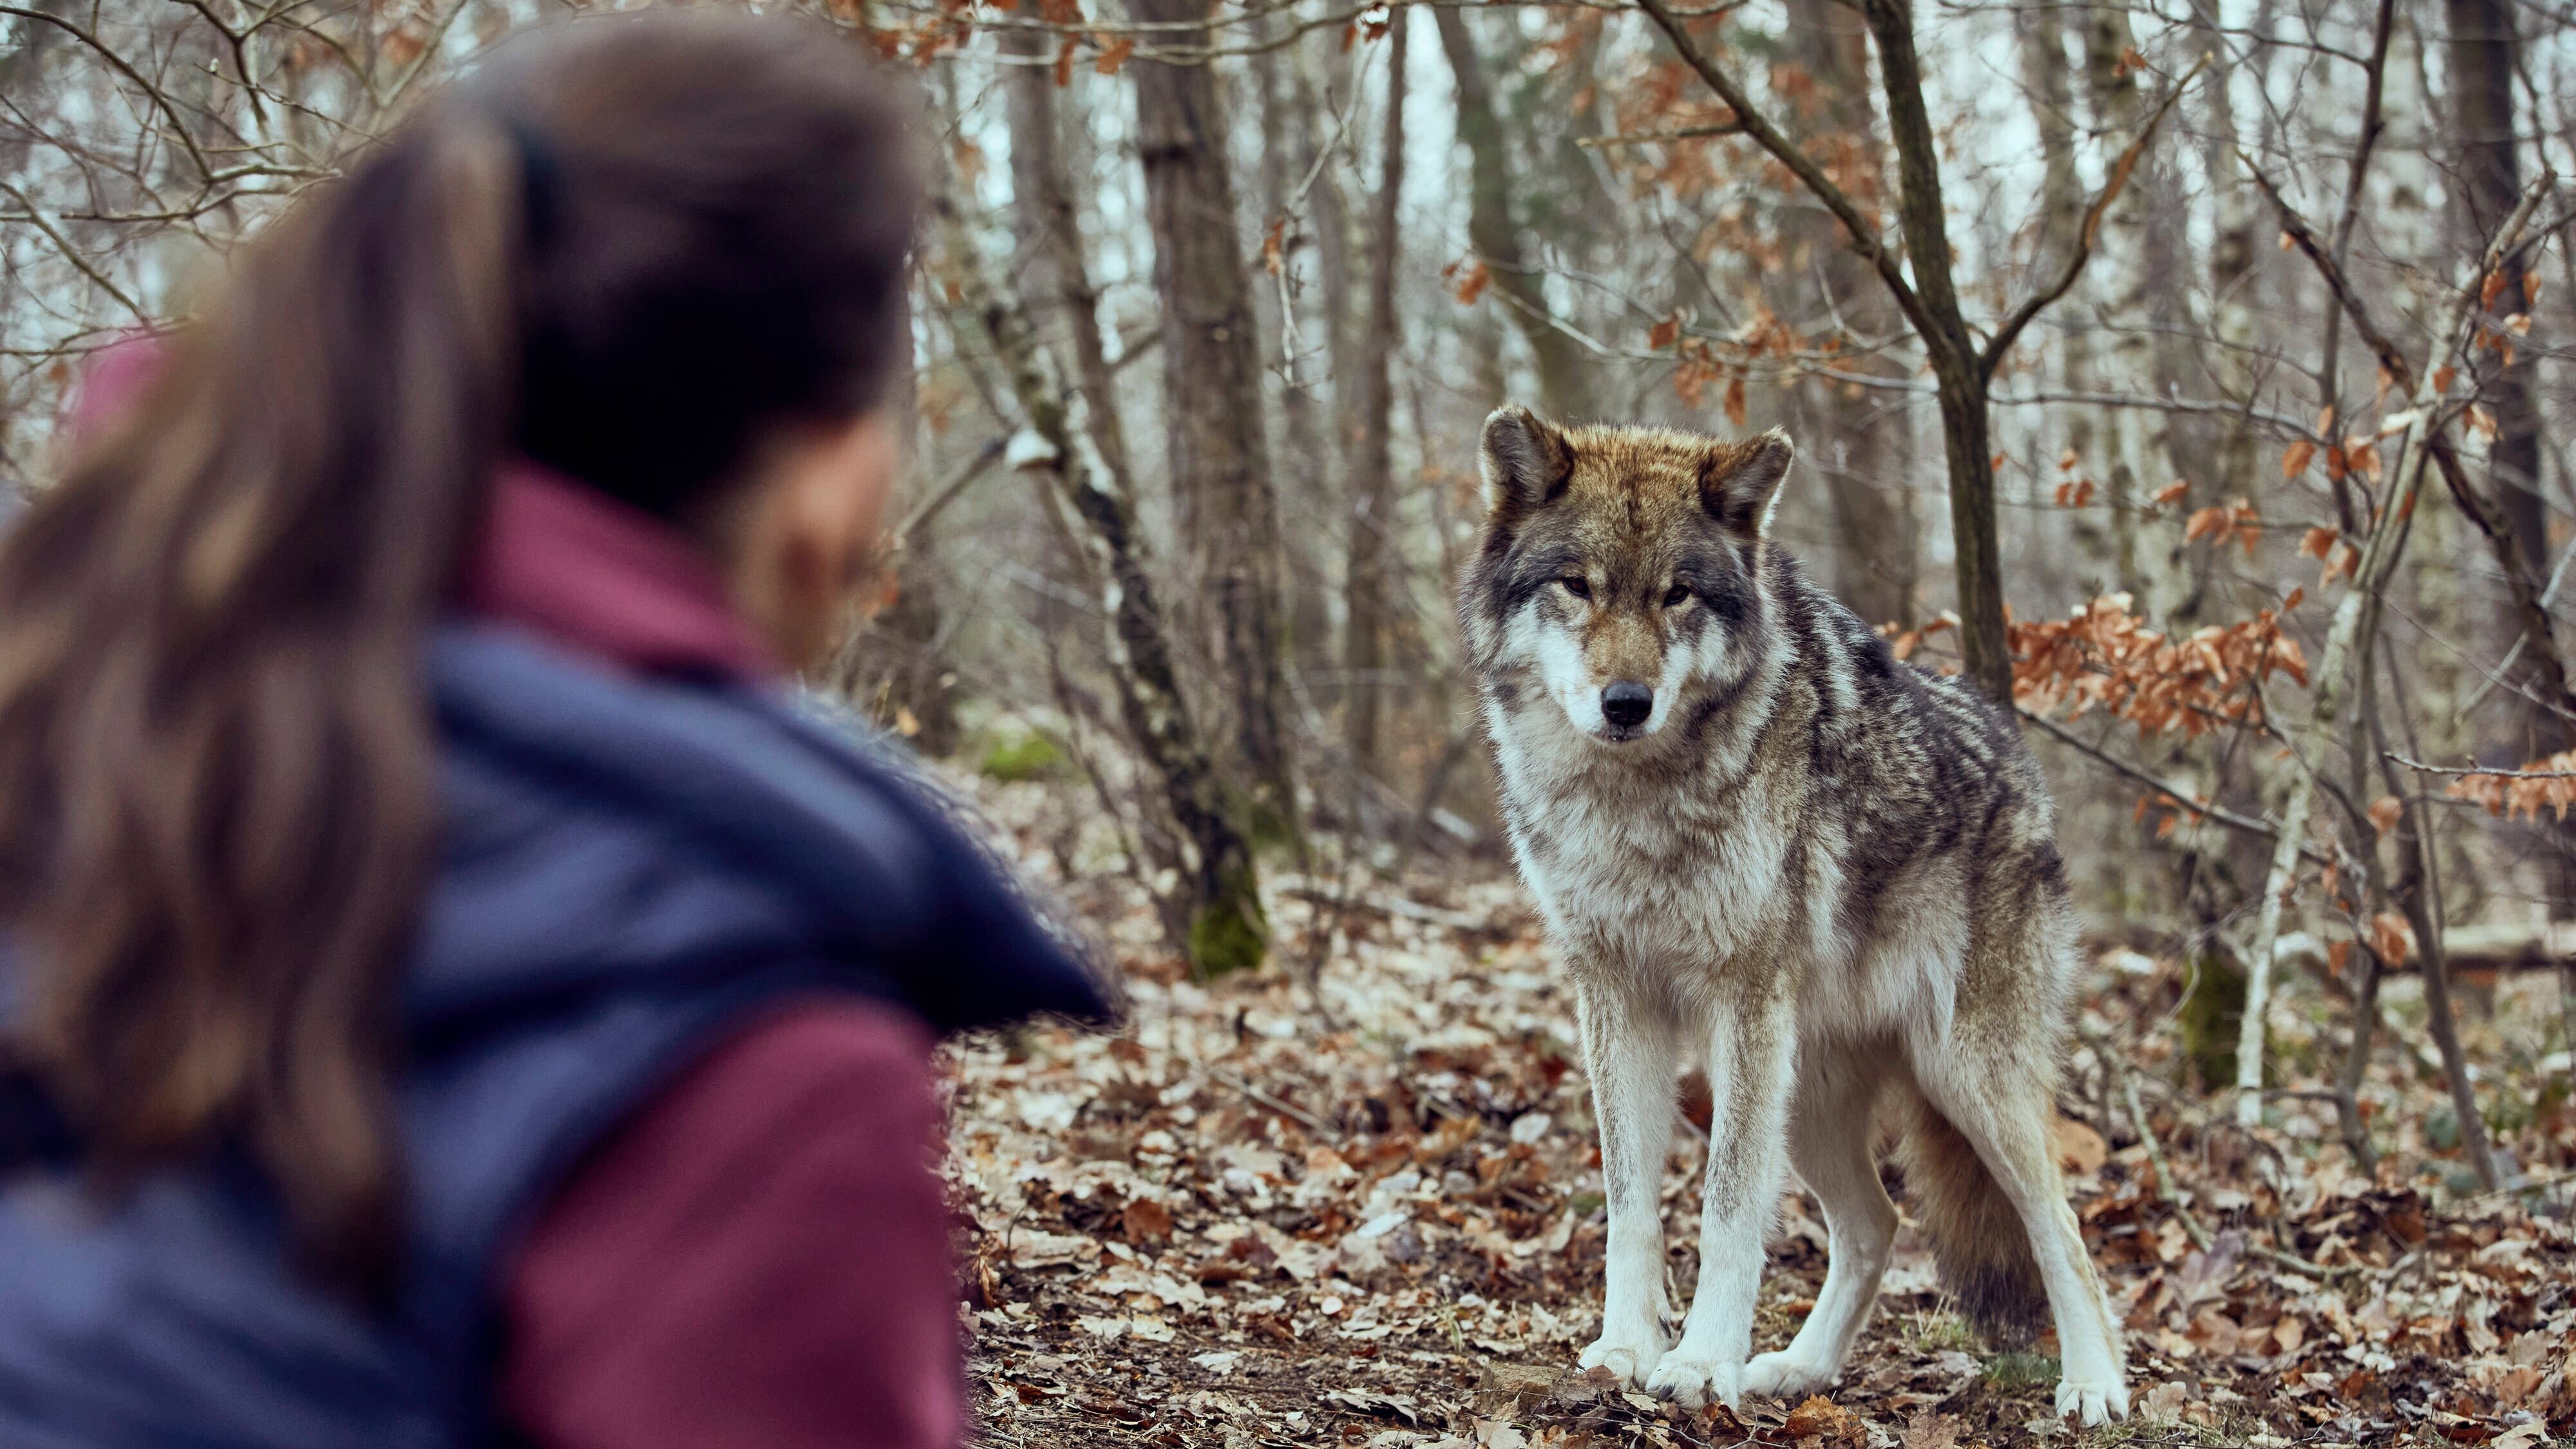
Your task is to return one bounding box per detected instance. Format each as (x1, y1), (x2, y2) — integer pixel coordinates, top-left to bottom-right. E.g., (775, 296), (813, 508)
(1646, 990), (1798, 1408)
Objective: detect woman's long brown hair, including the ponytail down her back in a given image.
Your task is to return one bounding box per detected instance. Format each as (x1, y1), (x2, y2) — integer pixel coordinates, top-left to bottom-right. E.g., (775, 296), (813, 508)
(0, 13), (920, 1289)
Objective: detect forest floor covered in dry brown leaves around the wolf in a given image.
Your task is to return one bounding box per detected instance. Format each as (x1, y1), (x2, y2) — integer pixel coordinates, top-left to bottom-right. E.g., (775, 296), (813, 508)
(948, 763), (2576, 1449)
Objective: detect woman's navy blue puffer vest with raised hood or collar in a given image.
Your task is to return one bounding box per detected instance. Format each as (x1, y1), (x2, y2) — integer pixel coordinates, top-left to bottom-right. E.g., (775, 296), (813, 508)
(0, 627), (1103, 1449)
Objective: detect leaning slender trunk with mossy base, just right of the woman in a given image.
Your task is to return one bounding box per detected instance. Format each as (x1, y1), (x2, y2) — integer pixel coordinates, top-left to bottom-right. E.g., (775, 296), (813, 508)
(933, 178), (1270, 977)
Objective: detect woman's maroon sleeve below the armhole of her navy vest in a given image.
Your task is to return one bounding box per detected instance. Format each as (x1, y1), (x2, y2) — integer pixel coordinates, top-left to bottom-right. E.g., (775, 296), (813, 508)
(500, 998), (963, 1449)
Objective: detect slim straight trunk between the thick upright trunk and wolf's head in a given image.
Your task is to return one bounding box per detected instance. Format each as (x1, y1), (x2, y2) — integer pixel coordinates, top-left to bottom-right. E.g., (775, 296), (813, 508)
(1342, 10), (1409, 776)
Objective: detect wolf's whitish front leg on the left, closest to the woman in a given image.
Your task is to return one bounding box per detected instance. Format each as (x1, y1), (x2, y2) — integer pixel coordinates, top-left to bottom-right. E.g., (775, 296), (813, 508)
(1574, 985), (1674, 1385)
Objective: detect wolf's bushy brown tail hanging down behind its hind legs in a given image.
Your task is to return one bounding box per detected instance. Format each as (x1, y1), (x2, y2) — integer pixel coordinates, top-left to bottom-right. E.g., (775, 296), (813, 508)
(1899, 1099), (2048, 1349)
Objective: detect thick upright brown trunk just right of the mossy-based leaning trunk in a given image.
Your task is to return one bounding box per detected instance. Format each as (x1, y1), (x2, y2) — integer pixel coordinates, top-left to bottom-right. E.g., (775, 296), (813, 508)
(1128, 0), (1296, 835)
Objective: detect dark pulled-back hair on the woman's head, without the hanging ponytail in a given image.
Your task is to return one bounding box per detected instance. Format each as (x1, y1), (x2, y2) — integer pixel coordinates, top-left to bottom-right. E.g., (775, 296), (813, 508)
(487, 15), (920, 518)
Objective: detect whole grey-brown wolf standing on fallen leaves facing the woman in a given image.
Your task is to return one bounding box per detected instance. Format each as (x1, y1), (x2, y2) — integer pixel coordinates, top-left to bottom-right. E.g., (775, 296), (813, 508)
(1461, 408), (2128, 1423)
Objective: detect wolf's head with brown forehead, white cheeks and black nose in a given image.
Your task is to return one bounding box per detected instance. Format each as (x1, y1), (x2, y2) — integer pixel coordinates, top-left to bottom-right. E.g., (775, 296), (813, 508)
(1461, 405), (1793, 745)
